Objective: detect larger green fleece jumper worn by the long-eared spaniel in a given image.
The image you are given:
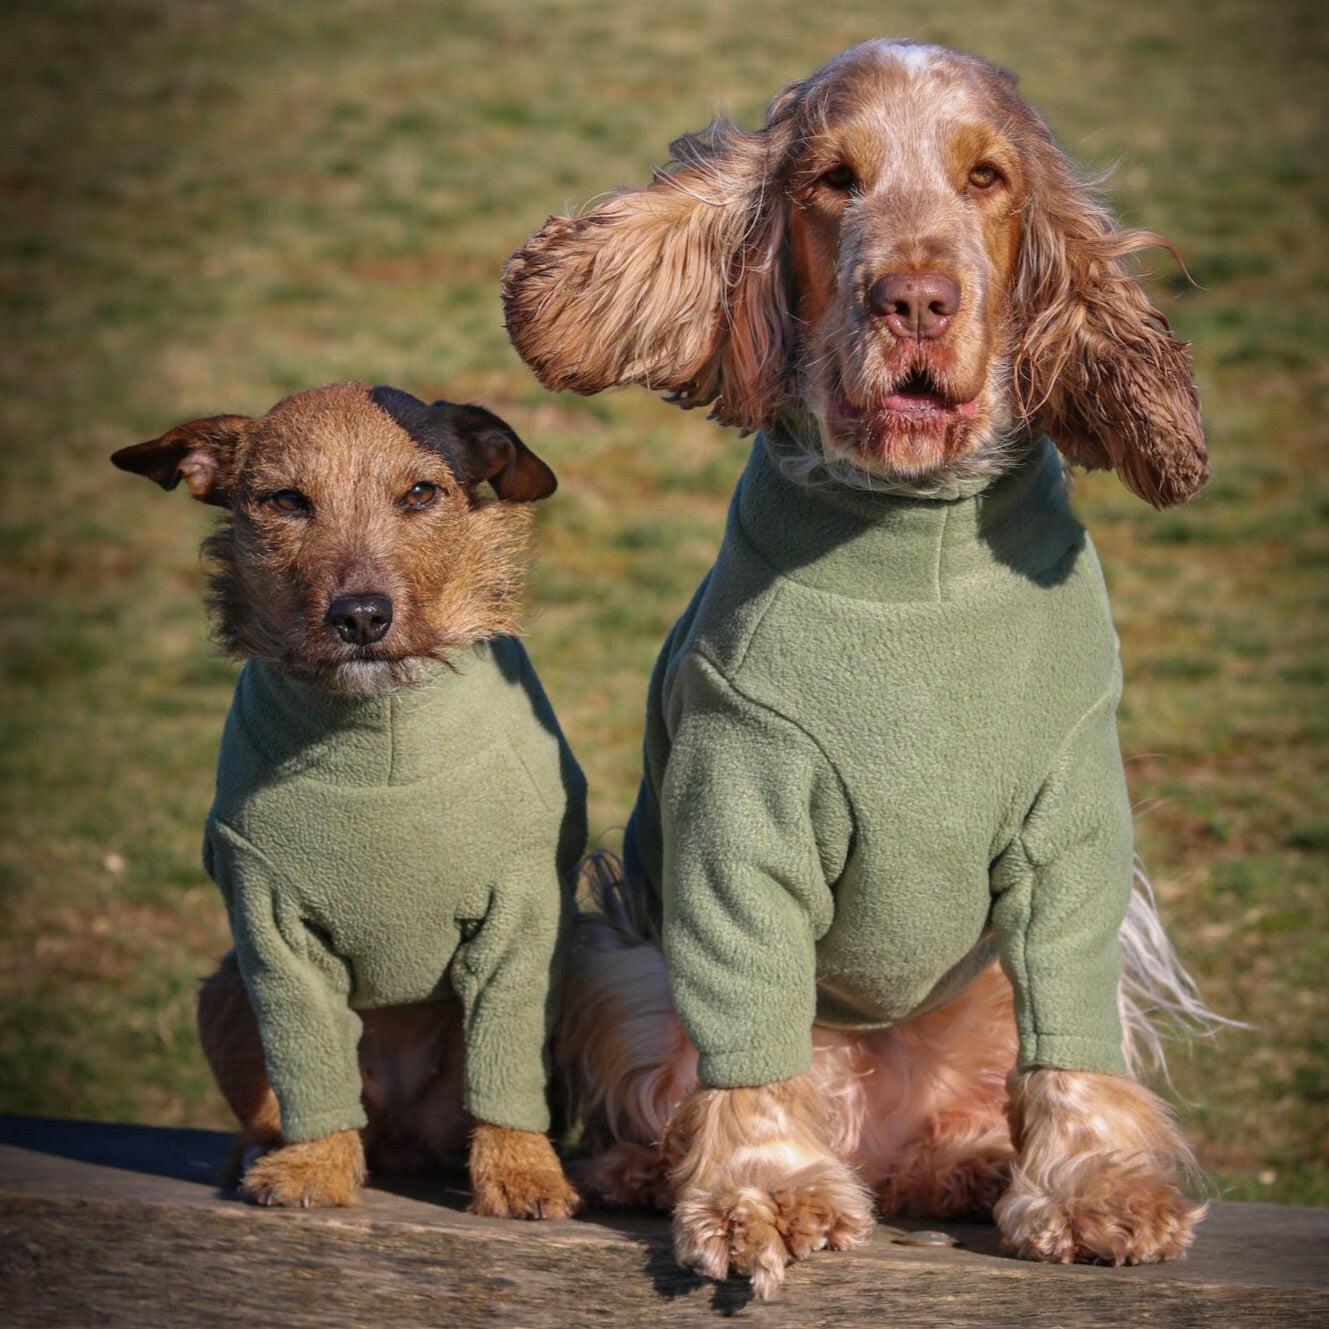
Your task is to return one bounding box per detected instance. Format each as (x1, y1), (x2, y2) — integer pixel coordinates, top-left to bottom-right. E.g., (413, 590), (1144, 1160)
(625, 435), (1132, 1086)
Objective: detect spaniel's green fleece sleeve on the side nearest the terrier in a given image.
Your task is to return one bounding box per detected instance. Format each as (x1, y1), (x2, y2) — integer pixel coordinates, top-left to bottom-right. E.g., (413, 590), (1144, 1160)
(661, 654), (851, 1087)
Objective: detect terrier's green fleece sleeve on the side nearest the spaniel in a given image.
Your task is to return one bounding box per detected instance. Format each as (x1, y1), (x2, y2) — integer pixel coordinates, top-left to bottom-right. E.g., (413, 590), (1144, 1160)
(451, 861), (567, 1131)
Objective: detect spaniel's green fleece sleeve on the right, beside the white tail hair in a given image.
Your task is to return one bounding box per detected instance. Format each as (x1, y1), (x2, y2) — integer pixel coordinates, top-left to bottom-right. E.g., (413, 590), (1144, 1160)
(993, 688), (1134, 1074)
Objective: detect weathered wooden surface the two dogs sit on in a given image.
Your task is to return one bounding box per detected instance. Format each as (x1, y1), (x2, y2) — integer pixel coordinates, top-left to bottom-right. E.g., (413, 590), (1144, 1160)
(0, 1118), (1329, 1329)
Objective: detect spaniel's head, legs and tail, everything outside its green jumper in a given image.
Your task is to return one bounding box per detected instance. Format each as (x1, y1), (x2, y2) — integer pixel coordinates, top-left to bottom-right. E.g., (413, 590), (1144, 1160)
(504, 41), (1208, 1296)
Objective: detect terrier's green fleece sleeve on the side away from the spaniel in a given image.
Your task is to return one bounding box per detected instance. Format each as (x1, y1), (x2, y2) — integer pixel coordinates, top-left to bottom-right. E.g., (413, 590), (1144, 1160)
(203, 820), (365, 1144)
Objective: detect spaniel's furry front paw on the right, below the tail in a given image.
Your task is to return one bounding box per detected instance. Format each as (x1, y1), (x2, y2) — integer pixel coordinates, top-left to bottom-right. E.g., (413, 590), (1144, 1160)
(993, 1155), (1205, 1264)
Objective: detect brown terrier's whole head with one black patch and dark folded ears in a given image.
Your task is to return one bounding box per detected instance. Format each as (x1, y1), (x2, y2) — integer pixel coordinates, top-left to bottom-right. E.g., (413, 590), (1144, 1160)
(112, 384), (556, 694)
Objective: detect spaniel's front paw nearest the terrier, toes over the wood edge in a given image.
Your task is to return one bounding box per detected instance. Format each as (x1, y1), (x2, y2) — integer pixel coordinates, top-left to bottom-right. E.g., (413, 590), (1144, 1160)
(674, 1158), (873, 1300)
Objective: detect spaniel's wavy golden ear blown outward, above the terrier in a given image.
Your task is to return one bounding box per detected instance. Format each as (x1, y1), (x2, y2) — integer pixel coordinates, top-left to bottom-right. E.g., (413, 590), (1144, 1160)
(502, 85), (797, 429)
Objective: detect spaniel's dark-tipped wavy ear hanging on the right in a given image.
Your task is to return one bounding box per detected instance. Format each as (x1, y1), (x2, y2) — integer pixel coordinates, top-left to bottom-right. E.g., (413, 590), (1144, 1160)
(1014, 134), (1209, 508)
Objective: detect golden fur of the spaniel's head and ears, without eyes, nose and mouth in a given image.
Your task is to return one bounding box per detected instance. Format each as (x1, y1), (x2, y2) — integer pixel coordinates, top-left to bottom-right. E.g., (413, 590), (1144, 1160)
(504, 43), (1207, 506)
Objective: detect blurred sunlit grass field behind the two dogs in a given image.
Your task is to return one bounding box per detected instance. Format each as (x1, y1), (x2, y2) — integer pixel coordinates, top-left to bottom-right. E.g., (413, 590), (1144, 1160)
(0, 0), (1329, 1204)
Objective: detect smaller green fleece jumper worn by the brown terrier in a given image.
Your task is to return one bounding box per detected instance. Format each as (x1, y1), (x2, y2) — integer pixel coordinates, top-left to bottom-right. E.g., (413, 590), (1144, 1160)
(203, 638), (586, 1142)
